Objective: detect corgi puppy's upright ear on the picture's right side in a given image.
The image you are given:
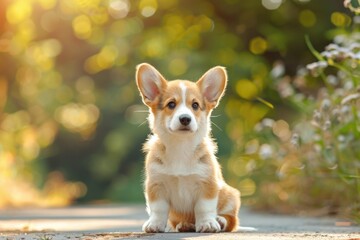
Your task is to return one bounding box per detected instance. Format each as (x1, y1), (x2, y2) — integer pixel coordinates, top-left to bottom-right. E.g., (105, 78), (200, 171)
(196, 66), (227, 109)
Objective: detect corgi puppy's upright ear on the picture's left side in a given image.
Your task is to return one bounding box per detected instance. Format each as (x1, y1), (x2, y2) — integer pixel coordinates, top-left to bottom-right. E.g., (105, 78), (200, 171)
(136, 63), (166, 107)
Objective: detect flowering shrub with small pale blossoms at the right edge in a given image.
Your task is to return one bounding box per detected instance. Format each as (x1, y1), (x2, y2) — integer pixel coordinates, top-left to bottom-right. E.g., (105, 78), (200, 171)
(243, 1), (360, 222)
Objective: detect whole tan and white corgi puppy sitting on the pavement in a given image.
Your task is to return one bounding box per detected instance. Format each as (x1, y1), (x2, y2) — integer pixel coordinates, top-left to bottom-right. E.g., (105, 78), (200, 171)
(136, 63), (240, 233)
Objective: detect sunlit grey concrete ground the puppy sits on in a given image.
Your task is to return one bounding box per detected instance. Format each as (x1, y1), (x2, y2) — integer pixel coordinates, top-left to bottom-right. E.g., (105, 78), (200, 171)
(0, 205), (360, 240)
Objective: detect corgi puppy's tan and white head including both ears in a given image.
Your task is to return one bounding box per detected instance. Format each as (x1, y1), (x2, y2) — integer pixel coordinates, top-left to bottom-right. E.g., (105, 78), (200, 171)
(136, 63), (227, 136)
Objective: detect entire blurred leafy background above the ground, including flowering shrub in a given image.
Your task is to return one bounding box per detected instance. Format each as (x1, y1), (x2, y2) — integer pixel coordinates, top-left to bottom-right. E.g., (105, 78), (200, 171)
(0, 0), (360, 219)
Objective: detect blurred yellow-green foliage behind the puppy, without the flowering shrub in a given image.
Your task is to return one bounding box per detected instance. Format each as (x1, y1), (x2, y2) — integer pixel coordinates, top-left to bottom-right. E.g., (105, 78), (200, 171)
(0, 0), (353, 221)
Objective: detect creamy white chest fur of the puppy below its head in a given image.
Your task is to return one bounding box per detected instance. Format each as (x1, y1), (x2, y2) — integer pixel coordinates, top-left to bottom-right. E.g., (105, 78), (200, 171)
(147, 135), (212, 212)
